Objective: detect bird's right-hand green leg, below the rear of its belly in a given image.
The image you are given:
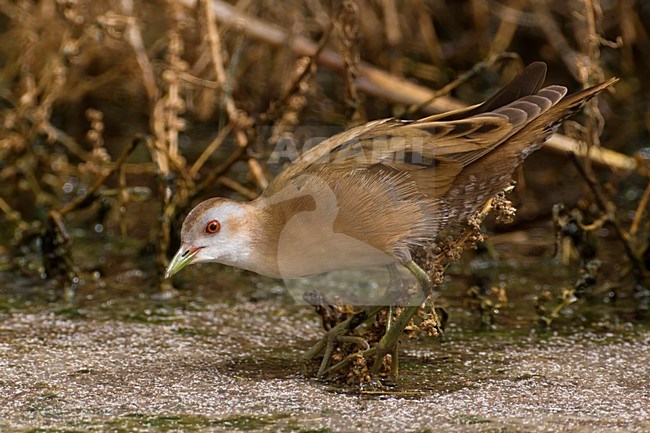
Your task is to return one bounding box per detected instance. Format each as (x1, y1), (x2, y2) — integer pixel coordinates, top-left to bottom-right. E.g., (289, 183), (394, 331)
(371, 261), (440, 378)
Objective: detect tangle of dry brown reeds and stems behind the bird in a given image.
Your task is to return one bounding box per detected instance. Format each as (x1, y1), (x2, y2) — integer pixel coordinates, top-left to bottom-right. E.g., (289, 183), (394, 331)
(0, 0), (650, 320)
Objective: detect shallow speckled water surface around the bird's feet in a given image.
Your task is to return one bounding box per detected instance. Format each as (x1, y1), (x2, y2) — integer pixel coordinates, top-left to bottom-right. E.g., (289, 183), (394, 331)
(0, 230), (650, 432)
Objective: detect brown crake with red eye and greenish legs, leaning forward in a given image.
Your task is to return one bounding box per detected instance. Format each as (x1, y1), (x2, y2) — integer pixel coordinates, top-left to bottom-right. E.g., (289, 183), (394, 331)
(166, 62), (617, 375)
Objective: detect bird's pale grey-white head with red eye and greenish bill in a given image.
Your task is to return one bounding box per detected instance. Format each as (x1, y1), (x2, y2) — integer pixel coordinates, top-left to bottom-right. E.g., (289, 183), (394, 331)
(165, 198), (252, 278)
